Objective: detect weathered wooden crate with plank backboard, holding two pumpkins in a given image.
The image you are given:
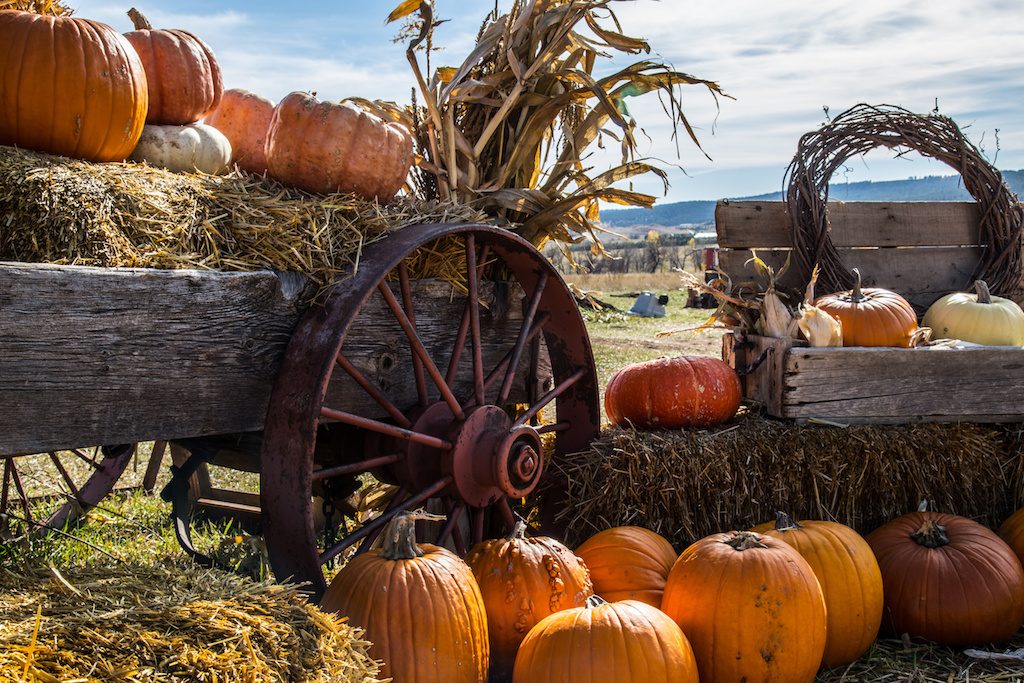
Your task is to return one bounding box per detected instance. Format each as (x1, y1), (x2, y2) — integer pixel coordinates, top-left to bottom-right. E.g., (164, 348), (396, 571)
(715, 202), (1024, 424)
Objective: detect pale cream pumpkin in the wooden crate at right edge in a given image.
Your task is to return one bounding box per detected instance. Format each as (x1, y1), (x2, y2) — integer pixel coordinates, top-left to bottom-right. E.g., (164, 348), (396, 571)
(922, 280), (1024, 346)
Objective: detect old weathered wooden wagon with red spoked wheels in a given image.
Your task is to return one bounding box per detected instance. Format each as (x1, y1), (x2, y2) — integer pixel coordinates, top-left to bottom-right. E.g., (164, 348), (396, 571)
(0, 224), (600, 595)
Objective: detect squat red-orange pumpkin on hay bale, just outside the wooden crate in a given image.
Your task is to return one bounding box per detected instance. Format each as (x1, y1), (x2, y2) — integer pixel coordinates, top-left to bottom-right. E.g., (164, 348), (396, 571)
(604, 356), (742, 429)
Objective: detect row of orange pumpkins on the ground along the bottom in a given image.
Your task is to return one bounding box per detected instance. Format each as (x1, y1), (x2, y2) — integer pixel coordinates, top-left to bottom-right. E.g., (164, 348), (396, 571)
(322, 506), (1024, 683)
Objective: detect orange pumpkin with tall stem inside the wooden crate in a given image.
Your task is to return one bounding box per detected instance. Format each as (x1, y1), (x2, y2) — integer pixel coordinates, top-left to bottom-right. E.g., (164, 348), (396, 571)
(814, 268), (918, 348)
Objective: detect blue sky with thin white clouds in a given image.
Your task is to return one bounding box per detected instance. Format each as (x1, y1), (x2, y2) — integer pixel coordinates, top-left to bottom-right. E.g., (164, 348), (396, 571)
(72, 0), (1024, 202)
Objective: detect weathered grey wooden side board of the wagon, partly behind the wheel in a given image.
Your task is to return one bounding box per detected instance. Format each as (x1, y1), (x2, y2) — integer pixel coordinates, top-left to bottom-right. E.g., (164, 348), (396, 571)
(0, 263), (543, 454)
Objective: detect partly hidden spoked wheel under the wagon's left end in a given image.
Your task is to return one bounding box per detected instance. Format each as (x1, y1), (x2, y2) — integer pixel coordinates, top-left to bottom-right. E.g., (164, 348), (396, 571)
(0, 443), (135, 539)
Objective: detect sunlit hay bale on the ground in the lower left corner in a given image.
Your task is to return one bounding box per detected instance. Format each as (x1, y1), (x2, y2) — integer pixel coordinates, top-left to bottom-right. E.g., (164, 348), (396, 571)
(0, 565), (380, 683)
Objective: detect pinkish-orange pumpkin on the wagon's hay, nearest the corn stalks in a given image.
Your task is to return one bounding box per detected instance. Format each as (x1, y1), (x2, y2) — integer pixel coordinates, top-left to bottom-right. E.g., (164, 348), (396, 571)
(266, 92), (413, 202)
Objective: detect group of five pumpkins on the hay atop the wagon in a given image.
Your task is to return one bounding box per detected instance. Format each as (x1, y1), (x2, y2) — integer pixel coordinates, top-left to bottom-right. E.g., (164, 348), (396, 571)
(0, 9), (413, 202)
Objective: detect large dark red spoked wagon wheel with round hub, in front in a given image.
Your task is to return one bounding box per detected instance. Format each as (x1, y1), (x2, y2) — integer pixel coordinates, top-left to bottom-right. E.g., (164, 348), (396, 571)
(260, 225), (600, 596)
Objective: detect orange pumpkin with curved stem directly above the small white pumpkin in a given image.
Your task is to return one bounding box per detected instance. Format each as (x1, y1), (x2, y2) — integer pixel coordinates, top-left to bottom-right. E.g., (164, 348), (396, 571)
(125, 7), (224, 125)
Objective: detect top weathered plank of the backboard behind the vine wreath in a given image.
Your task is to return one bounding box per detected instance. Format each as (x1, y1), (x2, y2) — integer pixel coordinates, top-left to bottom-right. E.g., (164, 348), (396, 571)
(715, 202), (980, 249)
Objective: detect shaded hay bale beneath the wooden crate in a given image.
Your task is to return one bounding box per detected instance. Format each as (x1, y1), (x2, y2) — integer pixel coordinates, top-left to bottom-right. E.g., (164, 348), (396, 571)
(553, 415), (1022, 548)
